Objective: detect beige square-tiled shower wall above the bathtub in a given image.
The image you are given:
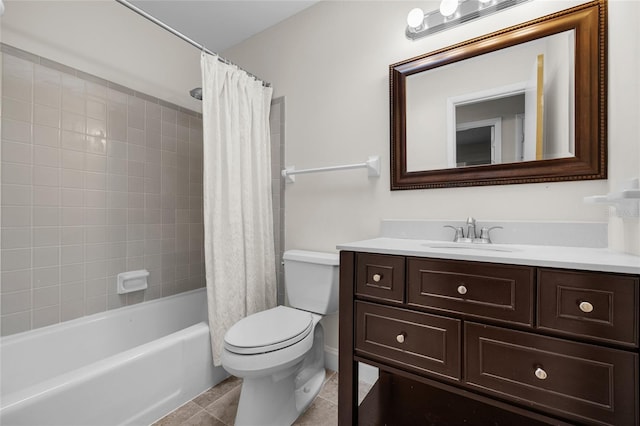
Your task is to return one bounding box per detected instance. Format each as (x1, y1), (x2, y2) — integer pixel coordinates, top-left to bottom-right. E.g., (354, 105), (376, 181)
(0, 45), (204, 335)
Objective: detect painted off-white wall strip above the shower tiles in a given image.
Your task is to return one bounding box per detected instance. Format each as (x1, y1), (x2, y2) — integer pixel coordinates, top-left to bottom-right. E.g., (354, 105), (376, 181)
(0, 0), (201, 111)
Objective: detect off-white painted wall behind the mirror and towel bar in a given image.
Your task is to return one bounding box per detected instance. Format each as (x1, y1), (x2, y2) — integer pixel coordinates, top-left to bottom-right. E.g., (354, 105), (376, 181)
(224, 0), (640, 347)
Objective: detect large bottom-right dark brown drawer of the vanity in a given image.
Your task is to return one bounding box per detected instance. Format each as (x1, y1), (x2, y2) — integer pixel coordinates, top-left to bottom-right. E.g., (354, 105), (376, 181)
(465, 322), (638, 425)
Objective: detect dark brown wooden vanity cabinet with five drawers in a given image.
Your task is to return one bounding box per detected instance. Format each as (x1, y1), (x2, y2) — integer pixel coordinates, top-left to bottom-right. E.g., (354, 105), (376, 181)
(339, 251), (640, 426)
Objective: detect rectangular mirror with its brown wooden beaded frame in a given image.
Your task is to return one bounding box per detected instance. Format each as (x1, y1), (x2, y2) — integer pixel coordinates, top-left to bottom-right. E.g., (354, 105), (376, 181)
(390, 0), (606, 190)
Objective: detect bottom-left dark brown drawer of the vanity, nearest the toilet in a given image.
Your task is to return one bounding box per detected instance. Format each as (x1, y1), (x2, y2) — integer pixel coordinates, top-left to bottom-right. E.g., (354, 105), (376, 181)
(355, 302), (461, 380)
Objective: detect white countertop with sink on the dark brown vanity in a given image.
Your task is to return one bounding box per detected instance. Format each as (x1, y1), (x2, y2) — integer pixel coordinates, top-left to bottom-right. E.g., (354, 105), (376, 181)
(337, 237), (640, 274)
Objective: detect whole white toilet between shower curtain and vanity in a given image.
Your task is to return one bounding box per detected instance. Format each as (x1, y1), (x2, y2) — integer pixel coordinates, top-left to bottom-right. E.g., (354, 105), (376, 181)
(222, 250), (339, 426)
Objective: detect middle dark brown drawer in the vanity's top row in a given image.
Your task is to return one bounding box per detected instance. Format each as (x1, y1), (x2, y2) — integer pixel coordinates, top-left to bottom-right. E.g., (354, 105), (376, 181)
(407, 258), (534, 326)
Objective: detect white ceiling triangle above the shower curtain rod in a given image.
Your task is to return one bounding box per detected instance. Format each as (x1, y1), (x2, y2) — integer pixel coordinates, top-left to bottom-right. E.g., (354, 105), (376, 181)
(130, 0), (318, 53)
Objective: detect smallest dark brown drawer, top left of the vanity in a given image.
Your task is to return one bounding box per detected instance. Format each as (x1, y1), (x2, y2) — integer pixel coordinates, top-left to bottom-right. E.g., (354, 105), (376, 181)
(356, 253), (404, 303)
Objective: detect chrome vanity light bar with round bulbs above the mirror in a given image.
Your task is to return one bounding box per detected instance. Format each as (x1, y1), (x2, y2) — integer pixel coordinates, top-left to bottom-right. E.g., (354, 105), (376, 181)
(405, 0), (529, 40)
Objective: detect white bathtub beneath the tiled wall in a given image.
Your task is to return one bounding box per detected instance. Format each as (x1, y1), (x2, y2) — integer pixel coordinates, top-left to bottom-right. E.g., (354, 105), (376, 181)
(0, 289), (228, 426)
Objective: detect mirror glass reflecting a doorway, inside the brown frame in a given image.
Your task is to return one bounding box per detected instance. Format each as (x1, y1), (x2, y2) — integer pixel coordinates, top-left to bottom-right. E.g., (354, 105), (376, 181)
(406, 30), (575, 171)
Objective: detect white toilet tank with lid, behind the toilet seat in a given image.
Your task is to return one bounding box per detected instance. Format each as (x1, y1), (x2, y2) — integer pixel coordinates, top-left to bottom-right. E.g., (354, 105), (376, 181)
(283, 250), (340, 315)
